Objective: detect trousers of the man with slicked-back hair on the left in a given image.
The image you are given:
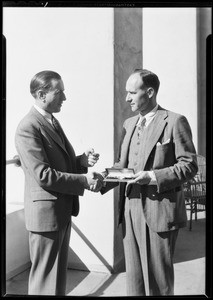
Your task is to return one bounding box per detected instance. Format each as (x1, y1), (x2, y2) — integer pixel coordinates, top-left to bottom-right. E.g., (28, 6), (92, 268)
(28, 221), (71, 295)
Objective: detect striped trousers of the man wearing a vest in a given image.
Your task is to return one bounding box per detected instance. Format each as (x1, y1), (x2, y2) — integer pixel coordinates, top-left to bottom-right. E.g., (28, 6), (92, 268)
(122, 198), (178, 296)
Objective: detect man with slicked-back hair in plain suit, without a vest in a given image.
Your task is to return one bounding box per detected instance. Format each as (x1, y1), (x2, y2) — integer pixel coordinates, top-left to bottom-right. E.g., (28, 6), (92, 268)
(15, 71), (102, 295)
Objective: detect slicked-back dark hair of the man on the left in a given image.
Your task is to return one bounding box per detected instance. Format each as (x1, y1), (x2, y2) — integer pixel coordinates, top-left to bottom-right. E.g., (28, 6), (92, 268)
(30, 71), (61, 97)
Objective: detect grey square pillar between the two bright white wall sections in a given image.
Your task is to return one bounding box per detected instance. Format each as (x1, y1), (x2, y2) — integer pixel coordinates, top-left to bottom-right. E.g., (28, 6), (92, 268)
(113, 8), (142, 271)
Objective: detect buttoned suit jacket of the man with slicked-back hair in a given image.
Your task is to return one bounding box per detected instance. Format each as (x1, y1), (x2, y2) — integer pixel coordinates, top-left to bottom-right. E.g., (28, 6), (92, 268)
(15, 107), (87, 232)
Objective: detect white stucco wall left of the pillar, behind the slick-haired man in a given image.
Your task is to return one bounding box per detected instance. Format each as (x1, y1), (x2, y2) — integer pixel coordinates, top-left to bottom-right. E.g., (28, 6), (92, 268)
(3, 7), (114, 270)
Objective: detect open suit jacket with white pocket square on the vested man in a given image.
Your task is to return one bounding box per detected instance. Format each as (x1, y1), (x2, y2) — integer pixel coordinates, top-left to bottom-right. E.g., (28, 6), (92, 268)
(101, 106), (198, 232)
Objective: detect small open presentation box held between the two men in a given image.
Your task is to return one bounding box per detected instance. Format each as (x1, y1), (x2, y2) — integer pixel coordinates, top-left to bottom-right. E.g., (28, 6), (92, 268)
(104, 168), (135, 182)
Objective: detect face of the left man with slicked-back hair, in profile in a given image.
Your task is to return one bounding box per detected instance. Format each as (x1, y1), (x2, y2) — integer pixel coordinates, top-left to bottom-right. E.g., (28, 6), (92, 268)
(44, 79), (66, 114)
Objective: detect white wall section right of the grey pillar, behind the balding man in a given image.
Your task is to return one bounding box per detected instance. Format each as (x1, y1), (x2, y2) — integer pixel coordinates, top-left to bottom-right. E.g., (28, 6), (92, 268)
(142, 7), (197, 149)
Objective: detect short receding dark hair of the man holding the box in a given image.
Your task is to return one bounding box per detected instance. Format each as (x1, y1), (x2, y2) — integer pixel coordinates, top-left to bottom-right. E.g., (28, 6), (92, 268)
(132, 69), (160, 94)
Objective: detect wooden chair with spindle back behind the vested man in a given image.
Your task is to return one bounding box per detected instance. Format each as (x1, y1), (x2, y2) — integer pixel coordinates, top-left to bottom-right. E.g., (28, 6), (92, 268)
(183, 155), (206, 230)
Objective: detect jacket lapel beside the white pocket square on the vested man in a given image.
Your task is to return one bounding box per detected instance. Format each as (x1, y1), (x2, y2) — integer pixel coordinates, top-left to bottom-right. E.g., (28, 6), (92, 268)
(140, 107), (167, 170)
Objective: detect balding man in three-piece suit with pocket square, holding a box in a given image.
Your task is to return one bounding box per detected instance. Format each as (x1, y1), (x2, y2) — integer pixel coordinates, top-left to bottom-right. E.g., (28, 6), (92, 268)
(100, 69), (197, 296)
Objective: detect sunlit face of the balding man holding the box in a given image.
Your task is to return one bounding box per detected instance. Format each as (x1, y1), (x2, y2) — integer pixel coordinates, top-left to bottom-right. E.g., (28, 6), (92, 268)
(126, 73), (151, 114)
